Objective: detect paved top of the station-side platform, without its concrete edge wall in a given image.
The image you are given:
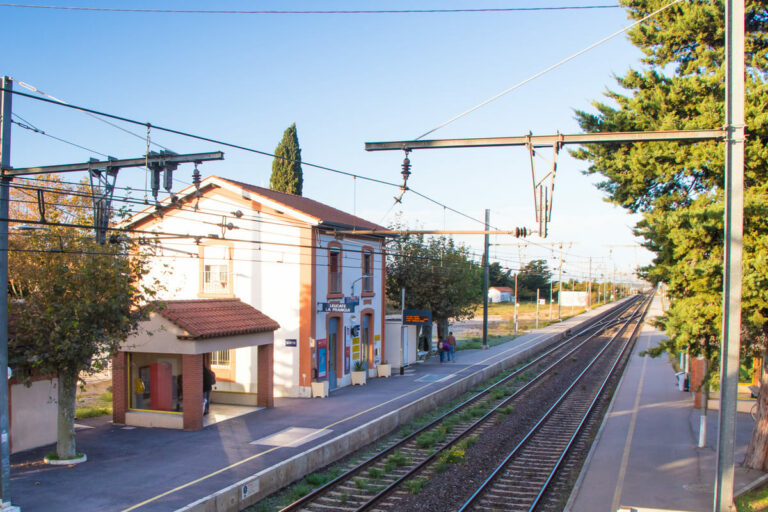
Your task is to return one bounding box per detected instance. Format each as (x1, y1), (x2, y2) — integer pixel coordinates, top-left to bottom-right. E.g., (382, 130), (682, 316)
(11, 308), (602, 512)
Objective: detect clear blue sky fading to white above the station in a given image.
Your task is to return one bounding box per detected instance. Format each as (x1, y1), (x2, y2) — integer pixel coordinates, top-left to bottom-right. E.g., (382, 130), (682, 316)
(0, 0), (651, 284)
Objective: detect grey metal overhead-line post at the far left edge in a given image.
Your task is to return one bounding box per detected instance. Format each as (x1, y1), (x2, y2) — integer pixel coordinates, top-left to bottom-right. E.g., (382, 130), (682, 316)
(0, 76), (13, 508)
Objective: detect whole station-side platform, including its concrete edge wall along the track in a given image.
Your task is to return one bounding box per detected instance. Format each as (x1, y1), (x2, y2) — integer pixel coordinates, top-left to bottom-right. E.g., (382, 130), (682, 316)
(11, 300), (606, 512)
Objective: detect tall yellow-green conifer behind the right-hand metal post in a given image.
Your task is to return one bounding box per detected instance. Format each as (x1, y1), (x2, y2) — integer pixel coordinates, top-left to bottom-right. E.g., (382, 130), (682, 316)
(574, 0), (768, 470)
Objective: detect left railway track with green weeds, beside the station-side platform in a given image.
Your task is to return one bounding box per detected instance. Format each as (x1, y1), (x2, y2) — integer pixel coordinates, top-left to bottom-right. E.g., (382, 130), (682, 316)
(282, 301), (638, 512)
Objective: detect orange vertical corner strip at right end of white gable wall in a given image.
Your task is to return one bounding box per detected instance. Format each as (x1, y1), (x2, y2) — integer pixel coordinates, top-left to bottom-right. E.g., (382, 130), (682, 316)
(299, 227), (316, 387)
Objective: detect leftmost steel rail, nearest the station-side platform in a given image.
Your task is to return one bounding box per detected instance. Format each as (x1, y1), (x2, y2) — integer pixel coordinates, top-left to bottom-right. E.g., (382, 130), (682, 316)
(280, 296), (632, 512)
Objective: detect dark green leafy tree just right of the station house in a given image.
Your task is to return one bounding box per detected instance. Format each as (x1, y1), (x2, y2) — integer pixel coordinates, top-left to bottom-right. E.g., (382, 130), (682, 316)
(387, 235), (483, 336)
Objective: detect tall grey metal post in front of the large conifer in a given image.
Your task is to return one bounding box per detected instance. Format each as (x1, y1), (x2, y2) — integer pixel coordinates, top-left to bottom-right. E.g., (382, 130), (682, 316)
(714, 0), (745, 512)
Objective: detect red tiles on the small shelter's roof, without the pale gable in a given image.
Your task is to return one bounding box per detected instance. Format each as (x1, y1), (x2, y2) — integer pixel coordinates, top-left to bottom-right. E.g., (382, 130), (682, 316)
(160, 299), (280, 339)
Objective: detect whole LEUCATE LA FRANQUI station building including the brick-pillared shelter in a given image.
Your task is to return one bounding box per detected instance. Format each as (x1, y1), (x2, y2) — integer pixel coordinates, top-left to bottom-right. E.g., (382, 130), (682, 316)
(113, 176), (387, 430)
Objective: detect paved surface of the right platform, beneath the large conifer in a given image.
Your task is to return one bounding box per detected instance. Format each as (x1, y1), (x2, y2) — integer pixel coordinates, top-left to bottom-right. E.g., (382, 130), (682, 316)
(566, 297), (763, 512)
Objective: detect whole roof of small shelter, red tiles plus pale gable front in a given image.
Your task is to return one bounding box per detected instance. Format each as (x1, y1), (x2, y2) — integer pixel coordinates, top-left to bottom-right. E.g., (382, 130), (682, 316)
(120, 299), (280, 354)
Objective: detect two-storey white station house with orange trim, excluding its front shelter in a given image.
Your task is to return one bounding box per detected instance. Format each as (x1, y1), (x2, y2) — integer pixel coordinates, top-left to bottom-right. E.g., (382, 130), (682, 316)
(121, 176), (386, 402)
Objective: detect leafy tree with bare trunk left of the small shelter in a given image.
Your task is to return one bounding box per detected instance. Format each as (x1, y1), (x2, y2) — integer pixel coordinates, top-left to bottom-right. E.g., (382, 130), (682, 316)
(8, 180), (160, 459)
